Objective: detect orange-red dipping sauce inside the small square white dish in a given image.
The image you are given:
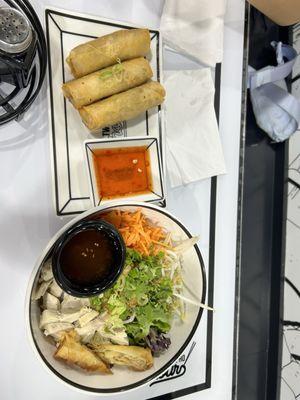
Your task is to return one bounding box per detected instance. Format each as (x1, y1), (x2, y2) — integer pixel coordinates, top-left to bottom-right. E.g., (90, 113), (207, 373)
(93, 146), (152, 200)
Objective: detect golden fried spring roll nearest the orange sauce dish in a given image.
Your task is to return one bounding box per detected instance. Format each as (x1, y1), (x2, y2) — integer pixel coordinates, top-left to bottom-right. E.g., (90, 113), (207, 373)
(79, 82), (165, 131)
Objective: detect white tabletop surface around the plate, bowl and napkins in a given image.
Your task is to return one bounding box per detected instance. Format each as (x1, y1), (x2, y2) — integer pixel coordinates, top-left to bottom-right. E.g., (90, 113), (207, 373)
(0, 0), (244, 400)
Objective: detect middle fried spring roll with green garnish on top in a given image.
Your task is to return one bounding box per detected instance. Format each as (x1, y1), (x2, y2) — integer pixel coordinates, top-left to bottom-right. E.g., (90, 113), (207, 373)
(62, 57), (153, 108)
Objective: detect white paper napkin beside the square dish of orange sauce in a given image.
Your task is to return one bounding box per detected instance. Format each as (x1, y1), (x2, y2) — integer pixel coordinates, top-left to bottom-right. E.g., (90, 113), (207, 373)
(165, 68), (226, 187)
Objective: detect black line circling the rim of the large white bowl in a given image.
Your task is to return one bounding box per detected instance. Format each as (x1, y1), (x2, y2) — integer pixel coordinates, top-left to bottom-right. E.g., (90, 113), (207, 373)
(29, 203), (207, 394)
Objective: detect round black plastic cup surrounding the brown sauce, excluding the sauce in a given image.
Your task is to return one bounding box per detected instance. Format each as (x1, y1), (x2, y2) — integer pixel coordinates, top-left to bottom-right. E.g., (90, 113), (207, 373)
(52, 219), (126, 298)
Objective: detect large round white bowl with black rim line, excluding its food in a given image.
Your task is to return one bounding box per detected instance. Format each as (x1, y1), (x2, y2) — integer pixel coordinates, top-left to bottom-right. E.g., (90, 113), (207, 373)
(25, 201), (206, 396)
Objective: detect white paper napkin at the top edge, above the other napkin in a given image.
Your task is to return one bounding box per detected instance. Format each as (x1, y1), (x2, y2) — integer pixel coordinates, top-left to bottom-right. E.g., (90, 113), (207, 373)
(160, 0), (226, 67)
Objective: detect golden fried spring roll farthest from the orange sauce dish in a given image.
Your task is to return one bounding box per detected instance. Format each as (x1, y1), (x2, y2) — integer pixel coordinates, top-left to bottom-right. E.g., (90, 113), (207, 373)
(66, 29), (150, 78)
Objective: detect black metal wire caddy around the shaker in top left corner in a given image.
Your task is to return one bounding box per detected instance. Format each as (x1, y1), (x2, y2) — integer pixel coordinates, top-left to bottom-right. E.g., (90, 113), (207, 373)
(0, 0), (47, 125)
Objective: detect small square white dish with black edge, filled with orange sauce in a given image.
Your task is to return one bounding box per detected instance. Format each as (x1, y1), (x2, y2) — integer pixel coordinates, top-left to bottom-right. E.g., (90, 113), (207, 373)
(84, 136), (165, 206)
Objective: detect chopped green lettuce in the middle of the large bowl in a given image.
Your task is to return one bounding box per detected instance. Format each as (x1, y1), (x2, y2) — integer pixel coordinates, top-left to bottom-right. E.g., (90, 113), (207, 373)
(90, 249), (173, 344)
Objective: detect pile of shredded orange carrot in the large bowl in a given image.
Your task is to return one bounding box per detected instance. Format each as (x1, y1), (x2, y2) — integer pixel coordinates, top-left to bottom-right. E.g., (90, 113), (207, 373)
(101, 209), (166, 255)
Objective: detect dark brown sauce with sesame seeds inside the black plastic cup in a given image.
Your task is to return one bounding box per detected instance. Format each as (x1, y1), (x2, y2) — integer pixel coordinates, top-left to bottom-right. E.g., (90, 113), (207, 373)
(60, 229), (115, 286)
